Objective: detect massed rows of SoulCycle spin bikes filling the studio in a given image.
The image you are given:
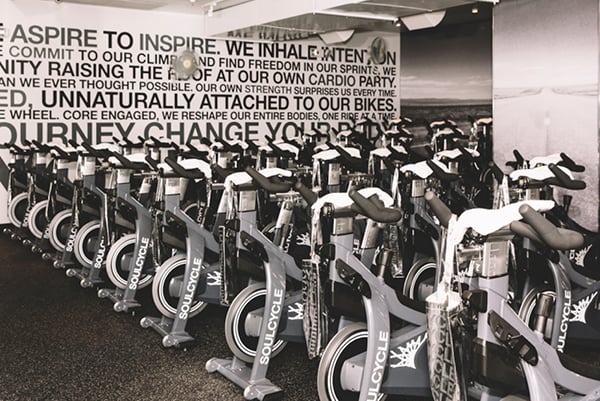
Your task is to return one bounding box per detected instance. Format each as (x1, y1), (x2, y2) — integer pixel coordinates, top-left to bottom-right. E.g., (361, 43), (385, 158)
(6, 118), (600, 401)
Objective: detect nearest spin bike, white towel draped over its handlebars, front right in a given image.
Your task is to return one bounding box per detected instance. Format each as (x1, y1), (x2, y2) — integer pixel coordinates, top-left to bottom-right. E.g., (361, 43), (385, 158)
(427, 194), (600, 401)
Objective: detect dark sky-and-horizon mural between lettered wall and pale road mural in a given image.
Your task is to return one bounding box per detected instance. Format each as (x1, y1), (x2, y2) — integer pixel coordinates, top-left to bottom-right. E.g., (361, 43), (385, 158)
(400, 5), (492, 138)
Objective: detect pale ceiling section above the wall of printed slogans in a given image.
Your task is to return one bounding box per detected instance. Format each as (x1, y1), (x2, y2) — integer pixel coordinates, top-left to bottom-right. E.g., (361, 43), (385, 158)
(44, 0), (499, 40)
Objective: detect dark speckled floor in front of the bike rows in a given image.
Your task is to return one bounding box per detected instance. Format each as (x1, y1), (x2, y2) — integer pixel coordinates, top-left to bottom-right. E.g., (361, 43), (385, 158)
(0, 231), (318, 401)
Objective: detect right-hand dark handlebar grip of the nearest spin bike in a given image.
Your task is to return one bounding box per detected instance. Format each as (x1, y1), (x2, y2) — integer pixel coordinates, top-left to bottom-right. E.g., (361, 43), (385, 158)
(519, 205), (584, 251)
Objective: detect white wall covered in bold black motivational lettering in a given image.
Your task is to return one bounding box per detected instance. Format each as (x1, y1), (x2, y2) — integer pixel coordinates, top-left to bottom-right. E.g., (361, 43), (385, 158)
(0, 0), (400, 223)
